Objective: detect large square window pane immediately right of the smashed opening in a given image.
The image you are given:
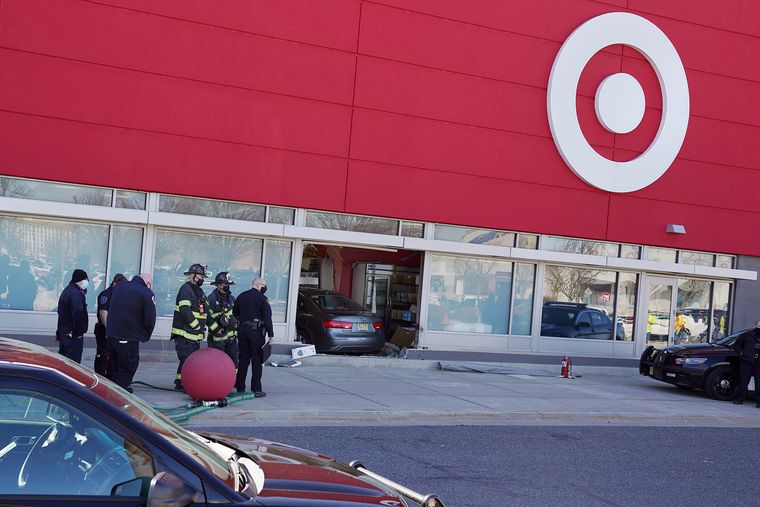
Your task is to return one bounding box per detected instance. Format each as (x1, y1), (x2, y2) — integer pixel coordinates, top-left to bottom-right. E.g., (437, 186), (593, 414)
(428, 255), (512, 334)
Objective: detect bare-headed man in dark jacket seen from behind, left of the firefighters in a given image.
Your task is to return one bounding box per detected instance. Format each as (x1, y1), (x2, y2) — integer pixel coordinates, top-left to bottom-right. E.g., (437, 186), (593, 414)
(106, 273), (156, 393)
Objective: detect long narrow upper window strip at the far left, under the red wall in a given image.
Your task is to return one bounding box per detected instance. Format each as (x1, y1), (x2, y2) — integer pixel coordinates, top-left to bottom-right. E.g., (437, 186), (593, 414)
(0, 177), (113, 206)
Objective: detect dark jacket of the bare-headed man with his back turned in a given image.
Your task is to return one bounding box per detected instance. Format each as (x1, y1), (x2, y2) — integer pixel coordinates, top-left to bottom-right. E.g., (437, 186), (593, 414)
(106, 276), (156, 342)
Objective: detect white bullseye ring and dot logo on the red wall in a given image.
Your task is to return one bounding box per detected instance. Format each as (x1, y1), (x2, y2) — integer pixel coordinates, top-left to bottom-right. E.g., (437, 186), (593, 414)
(546, 12), (689, 192)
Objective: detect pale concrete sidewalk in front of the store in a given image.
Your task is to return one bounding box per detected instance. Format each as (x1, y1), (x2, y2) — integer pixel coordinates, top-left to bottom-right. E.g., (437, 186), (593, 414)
(70, 351), (760, 427)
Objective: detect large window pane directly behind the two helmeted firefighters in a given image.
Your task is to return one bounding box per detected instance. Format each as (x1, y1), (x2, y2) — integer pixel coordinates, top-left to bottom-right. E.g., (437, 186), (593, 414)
(153, 230), (264, 316)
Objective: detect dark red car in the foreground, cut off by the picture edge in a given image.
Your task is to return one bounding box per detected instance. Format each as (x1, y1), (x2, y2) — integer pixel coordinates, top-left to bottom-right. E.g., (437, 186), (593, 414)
(0, 338), (443, 507)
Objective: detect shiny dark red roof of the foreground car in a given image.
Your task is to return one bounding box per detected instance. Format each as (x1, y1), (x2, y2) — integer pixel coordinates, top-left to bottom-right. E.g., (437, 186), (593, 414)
(0, 337), (98, 387)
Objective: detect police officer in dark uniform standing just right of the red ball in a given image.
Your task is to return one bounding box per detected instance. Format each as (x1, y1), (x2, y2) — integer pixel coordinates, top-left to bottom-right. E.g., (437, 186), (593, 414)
(238, 278), (274, 398)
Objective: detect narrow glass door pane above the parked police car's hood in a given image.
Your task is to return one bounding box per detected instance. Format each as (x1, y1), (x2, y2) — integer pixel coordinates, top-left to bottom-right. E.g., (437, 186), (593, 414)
(646, 277), (683, 349)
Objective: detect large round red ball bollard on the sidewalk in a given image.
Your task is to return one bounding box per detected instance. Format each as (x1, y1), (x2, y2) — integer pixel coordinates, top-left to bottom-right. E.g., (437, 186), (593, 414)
(182, 349), (235, 401)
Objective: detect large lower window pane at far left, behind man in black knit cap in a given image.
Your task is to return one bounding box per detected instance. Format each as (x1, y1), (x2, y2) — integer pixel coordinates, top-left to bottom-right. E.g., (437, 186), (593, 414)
(0, 216), (108, 312)
